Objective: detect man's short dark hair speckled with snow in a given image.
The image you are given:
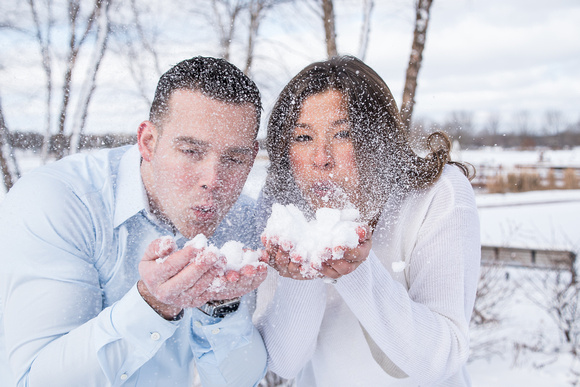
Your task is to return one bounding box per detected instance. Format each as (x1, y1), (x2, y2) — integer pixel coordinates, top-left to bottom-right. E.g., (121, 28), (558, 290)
(149, 56), (262, 130)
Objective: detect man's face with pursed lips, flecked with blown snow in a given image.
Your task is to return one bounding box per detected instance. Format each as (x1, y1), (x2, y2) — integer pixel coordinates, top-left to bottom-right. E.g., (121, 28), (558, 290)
(139, 90), (258, 238)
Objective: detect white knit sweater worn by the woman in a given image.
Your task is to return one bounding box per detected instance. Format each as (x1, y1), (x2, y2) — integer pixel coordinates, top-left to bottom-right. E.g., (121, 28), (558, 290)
(254, 166), (481, 387)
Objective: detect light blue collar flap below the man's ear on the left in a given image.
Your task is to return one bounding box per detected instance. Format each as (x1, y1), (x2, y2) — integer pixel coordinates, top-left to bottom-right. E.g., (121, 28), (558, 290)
(113, 145), (149, 228)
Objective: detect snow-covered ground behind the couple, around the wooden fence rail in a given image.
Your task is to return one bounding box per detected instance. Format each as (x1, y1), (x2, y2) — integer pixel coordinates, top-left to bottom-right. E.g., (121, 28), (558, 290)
(0, 148), (580, 387)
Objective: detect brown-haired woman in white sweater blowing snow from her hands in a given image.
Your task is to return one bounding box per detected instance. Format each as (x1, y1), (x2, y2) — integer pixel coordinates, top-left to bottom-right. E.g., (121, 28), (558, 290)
(256, 57), (481, 386)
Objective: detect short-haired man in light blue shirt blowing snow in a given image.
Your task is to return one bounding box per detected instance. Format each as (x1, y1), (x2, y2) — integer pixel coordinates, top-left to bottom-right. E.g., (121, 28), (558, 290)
(0, 57), (266, 386)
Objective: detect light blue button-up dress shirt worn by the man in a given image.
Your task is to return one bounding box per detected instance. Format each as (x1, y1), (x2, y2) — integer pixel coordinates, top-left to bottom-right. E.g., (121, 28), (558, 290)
(0, 146), (266, 387)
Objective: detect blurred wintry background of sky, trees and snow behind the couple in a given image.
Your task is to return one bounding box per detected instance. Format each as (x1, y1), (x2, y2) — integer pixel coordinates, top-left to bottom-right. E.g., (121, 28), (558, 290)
(0, 0), (580, 386)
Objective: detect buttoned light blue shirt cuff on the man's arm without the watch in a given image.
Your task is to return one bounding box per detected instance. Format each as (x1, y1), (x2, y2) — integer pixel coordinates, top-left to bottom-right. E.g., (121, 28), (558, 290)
(111, 284), (180, 356)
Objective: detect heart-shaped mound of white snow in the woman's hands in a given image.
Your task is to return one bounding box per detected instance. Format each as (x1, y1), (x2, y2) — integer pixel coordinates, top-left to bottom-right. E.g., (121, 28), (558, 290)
(262, 203), (365, 277)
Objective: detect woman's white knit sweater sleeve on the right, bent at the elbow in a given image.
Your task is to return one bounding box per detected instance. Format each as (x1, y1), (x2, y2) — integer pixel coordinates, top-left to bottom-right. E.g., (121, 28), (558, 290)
(335, 175), (481, 385)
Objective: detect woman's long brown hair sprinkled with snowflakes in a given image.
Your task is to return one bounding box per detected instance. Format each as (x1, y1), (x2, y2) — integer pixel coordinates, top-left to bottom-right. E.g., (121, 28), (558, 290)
(265, 56), (474, 223)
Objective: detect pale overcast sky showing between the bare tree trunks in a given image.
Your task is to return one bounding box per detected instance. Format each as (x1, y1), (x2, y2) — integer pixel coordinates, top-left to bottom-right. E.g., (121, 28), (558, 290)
(0, 0), (580, 136)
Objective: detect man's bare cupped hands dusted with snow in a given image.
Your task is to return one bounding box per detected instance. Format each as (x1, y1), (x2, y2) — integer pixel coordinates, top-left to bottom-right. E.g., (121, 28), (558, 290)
(137, 238), (267, 320)
